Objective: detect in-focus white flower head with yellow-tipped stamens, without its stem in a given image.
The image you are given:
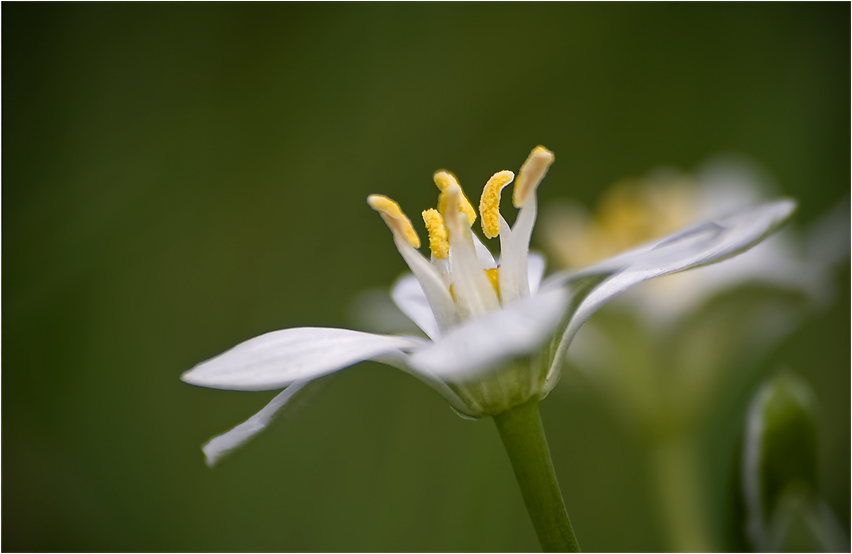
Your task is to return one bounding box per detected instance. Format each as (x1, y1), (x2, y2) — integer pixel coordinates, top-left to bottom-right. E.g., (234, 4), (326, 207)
(181, 146), (795, 465)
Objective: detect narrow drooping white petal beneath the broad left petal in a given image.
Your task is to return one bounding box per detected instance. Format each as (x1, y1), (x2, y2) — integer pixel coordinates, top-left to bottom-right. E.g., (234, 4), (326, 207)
(201, 379), (325, 467)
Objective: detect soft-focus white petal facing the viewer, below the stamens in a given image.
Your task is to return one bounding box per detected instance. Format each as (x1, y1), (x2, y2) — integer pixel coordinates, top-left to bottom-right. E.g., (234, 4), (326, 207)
(409, 289), (569, 382)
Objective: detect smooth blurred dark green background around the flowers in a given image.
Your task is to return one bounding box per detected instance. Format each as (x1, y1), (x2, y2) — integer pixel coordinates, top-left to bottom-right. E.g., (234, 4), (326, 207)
(2, 3), (850, 551)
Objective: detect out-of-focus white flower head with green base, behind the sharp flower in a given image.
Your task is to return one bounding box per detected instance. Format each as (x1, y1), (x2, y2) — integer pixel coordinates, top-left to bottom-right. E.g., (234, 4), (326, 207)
(542, 157), (849, 427)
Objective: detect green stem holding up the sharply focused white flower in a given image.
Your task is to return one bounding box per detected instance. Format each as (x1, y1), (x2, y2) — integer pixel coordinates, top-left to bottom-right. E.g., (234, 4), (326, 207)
(494, 400), (580, 552)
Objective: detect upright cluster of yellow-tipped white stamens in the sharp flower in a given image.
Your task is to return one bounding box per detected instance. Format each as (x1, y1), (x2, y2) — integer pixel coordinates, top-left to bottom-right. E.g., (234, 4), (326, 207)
(367, 146), (554, 322)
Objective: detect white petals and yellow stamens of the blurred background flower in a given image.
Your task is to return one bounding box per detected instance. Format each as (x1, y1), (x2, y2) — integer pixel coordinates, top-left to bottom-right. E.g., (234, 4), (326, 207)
(543, 156), (849, 327)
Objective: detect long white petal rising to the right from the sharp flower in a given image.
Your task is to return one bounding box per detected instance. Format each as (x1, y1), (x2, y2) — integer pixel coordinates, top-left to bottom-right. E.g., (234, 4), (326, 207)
(545, 196), (796, 374)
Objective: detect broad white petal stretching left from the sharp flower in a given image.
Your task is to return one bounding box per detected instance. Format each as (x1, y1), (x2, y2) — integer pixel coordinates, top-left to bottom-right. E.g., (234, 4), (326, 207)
(181, 327), (428, 391)
